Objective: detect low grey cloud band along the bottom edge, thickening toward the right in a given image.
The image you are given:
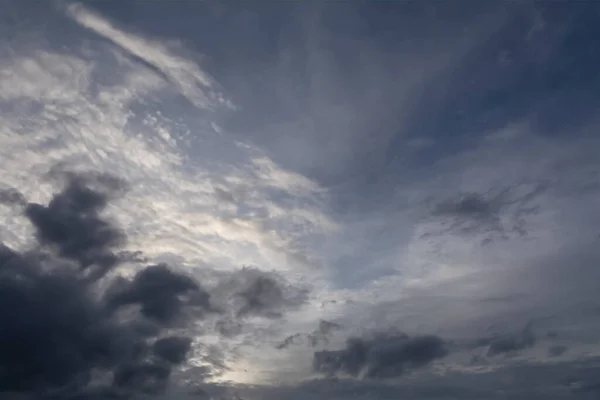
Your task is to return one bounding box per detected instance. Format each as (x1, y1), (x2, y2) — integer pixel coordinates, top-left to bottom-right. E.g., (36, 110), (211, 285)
(237, 358), (600, 400)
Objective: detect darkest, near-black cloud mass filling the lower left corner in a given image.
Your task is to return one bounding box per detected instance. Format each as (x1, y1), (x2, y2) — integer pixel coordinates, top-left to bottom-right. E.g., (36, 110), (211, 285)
(0, 244), (183, 393)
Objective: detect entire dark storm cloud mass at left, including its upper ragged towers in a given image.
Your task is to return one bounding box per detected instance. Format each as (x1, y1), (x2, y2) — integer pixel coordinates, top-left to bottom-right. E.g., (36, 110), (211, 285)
(0, 171), (208, 399)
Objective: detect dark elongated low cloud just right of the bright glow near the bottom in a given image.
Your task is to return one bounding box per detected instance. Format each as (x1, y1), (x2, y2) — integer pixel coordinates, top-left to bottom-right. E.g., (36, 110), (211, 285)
(313, 334), (448, 379)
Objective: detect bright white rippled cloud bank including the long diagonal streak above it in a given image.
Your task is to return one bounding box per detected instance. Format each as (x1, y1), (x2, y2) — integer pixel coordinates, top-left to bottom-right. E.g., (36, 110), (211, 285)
(0, 6), (335, 276)
